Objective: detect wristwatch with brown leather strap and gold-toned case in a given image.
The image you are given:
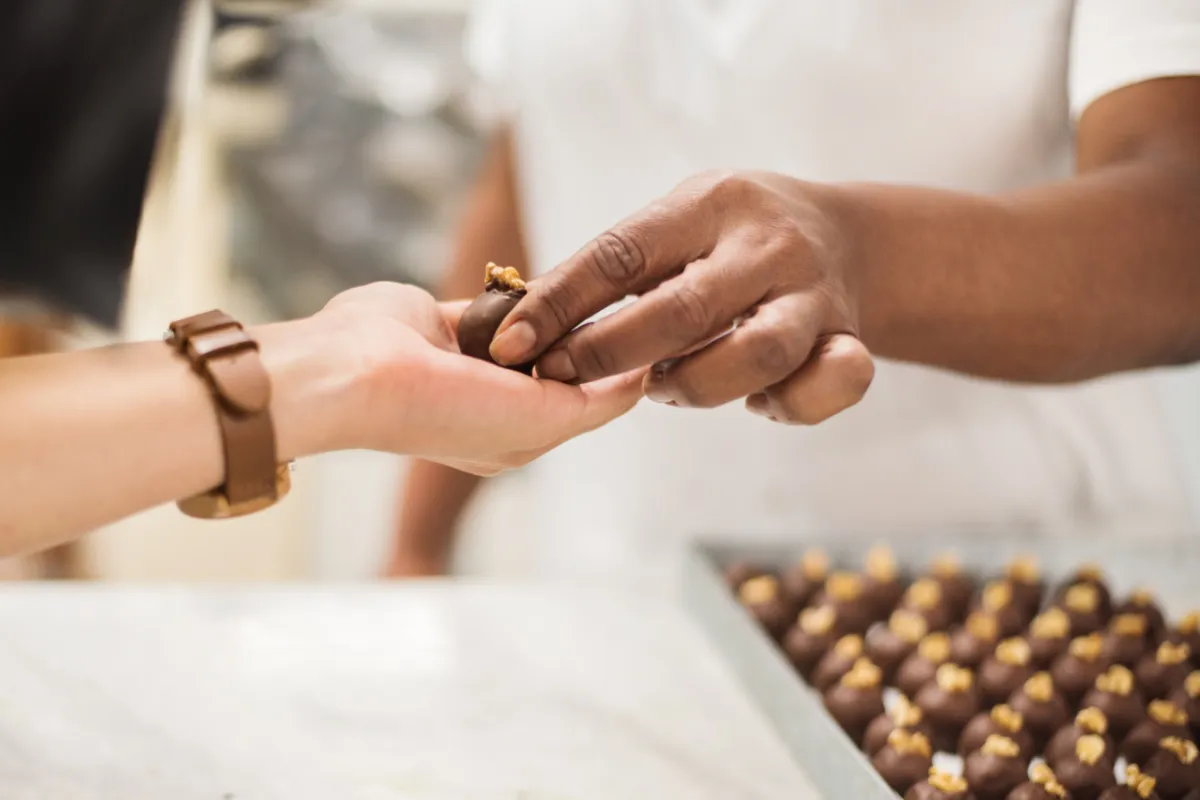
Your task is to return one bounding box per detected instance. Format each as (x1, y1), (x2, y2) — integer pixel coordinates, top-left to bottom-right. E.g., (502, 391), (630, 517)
(164, 311), (292, 519)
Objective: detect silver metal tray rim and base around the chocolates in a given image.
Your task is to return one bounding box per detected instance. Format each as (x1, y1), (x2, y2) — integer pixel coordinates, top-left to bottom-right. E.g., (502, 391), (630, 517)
(684, 534), (1200, 800)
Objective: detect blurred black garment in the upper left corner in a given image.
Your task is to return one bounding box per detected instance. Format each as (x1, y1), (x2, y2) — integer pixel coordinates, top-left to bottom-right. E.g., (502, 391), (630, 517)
(0, 0), (184, 325)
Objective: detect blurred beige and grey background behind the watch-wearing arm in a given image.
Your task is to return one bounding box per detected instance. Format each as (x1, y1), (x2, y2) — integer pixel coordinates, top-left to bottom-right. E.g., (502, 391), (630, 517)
(0, 0), (535, 581)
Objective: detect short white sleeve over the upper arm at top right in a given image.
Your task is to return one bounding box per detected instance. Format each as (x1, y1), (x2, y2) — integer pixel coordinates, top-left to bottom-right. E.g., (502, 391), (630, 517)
(1070, 0), (1200, 119)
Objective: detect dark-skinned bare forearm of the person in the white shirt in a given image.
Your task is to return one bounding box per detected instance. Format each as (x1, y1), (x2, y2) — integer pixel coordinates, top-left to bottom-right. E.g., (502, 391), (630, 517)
(834, 161), (1200, 381)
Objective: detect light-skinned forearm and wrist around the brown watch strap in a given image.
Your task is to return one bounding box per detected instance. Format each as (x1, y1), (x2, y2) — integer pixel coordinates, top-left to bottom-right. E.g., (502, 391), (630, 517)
(0, 321), (350, 554)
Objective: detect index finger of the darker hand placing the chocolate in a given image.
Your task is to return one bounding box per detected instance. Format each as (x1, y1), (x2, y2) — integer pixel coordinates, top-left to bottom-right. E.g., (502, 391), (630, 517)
(491, 193), (716, 365)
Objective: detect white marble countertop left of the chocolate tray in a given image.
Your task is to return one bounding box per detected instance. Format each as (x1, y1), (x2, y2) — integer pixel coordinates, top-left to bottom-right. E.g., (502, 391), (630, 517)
(0, 583), (816, 800)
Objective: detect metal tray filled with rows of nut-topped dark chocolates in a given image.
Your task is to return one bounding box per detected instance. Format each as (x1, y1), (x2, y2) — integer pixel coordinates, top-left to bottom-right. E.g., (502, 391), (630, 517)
(686, 537), (1200, 800)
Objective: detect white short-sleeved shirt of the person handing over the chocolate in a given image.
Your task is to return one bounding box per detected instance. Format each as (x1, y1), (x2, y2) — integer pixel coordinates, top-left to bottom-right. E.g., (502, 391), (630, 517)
(469, 0), (1200, 594)
